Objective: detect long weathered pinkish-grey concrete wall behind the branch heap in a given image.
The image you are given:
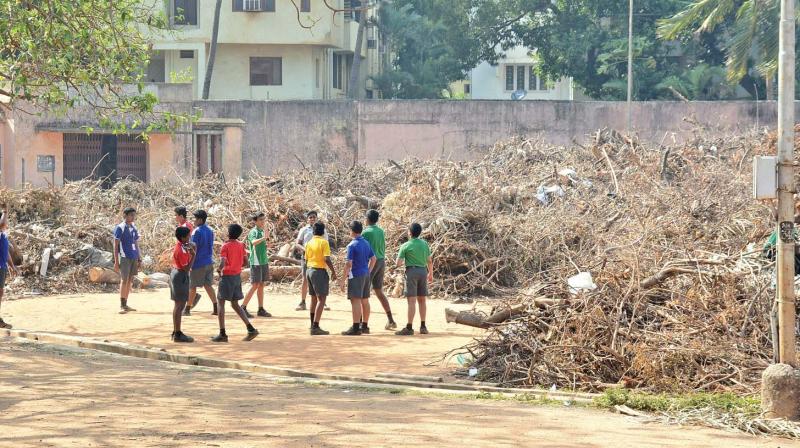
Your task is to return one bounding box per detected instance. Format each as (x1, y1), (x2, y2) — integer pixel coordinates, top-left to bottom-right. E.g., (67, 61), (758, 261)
(195, 101), (777, 173)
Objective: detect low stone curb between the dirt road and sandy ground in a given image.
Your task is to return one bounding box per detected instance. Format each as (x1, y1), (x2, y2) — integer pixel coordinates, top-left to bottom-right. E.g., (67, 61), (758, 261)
(3, 329), (598, 404)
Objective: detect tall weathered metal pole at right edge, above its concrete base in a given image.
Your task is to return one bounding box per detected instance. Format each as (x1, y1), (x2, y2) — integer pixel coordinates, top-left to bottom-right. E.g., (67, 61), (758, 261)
(777, 0), (797, 367)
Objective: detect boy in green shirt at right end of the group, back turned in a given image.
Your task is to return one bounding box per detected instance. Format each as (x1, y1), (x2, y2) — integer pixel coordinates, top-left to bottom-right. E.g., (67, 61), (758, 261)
(395, 223), (433, 336)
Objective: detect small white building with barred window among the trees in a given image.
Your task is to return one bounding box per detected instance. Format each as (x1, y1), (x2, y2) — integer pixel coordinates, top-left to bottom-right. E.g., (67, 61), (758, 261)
(465, 46), (574, 101)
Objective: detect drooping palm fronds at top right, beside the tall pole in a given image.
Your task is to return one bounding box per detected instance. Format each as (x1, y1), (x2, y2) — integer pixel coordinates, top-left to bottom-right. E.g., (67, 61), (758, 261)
(658, 0), (780, 97)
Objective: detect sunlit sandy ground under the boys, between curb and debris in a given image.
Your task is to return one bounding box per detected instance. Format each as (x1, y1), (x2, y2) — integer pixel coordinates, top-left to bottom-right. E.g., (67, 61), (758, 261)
(0, 287), (483, 377)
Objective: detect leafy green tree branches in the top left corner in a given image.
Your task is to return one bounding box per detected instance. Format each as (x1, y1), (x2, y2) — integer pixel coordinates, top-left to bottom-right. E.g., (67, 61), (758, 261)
(0, 0), (189, 133)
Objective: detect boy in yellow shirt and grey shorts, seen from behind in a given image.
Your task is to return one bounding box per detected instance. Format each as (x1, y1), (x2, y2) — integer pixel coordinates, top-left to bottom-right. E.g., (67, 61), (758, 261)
(305, 222), (336, 336)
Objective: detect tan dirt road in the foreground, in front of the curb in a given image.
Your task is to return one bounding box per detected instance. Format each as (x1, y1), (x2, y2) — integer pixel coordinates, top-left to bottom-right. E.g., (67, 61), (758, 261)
(0, 339), (800, 448)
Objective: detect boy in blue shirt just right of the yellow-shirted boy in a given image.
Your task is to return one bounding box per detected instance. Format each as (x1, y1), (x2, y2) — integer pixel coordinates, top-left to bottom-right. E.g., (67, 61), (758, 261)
(342, 221), (377, 336)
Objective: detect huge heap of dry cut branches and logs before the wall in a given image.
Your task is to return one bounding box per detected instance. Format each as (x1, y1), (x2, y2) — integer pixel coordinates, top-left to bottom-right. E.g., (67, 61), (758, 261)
(0, 130), (773, 391)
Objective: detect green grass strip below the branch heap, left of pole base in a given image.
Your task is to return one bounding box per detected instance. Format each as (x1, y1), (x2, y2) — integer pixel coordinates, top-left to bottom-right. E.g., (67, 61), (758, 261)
(594, 389), (761, 417)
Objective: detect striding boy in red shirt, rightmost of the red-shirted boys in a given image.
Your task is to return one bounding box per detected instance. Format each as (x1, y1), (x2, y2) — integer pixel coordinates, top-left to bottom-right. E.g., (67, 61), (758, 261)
(211, 224), (258, 342)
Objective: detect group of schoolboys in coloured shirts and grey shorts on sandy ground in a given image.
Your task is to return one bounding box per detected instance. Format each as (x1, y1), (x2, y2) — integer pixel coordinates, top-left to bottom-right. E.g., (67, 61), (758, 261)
(109, 207), (433, 343)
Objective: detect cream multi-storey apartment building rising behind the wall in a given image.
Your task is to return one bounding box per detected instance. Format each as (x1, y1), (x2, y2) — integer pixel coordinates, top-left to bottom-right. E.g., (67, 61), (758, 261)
(152, 0), (384, 100)
